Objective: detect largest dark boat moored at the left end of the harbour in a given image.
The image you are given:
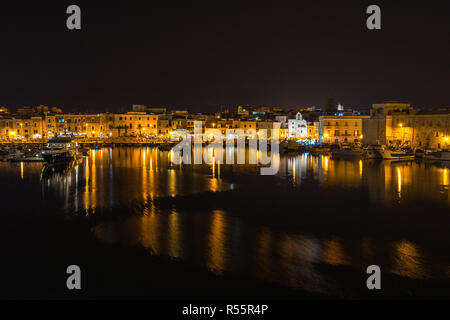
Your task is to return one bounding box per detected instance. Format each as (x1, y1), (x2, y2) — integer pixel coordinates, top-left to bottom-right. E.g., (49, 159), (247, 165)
(41, 137), (76, 164)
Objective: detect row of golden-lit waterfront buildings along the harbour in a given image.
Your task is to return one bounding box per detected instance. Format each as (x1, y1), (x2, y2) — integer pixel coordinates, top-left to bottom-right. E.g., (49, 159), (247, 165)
(0, 102), (450, 149)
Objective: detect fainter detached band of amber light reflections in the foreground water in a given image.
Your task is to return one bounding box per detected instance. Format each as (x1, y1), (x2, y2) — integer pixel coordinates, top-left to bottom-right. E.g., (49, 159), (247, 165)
(94, 215), (436, 294)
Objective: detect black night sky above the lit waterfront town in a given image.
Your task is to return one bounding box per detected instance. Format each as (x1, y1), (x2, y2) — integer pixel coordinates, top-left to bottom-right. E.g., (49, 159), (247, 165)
(0, 0), (450, 111)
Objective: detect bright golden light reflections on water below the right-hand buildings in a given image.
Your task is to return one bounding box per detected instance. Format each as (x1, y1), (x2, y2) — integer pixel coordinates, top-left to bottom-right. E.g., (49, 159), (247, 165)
(280, 154), (450, 205)
